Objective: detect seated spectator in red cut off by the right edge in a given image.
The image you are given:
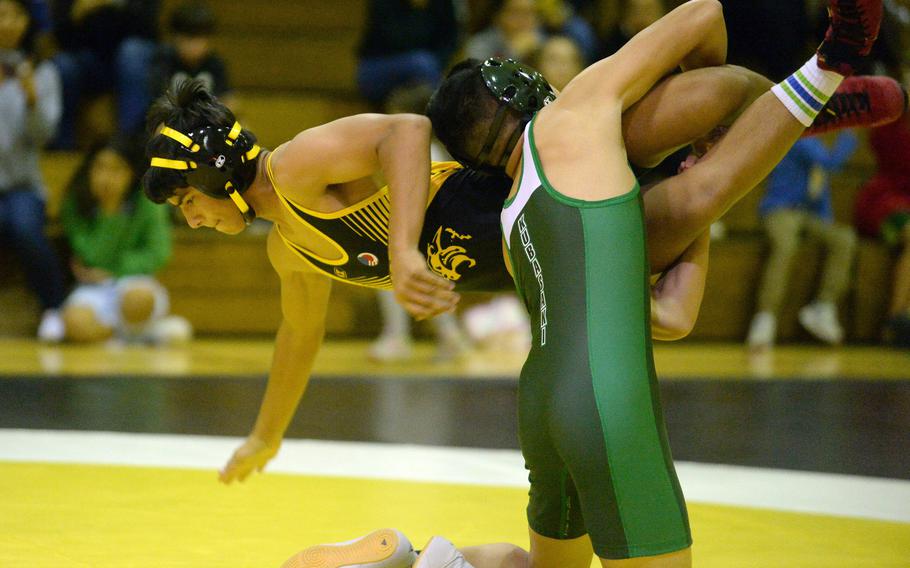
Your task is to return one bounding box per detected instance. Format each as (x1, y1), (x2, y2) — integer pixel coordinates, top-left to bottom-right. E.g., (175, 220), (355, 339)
(854, 114), (910, 347)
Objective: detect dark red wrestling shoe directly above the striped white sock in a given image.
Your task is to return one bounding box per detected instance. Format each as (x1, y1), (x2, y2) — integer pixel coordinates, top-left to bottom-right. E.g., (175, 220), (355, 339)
(818, 0), (882, 77)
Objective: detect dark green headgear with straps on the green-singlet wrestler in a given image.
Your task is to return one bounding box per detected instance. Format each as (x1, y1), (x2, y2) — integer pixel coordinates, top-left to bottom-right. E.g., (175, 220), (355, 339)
(470, 57), (556, 172)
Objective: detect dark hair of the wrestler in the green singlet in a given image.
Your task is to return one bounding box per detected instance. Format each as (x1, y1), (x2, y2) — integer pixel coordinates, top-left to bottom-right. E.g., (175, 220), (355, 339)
(426, 59), (518, 168)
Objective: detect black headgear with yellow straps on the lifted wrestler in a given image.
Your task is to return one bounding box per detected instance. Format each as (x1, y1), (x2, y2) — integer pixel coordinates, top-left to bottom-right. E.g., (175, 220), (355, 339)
(151, 121), (260, 225)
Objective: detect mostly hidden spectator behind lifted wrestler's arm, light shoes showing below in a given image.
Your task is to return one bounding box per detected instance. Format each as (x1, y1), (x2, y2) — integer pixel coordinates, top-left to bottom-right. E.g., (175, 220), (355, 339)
(367, 85), (470, 363)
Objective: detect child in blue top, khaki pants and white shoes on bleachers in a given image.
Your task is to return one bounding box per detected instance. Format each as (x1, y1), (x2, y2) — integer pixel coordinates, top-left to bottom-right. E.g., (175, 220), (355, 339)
(747, 132), (856, 350)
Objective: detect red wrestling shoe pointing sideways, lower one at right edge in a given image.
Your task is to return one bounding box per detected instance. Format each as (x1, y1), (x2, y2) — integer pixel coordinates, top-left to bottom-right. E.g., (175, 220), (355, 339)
(803, 75), (908, 136)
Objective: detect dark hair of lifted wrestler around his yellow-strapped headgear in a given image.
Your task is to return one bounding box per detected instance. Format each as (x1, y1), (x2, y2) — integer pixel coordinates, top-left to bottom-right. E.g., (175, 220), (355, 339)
(142, 79), (257, 203)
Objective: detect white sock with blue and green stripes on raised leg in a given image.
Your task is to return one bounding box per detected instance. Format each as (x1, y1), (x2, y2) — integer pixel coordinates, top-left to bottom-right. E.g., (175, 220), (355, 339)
(771, 55), (844, 127)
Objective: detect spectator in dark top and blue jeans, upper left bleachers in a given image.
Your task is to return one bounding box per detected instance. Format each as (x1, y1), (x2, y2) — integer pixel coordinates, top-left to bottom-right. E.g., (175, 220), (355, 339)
(52, 0), (160, 149)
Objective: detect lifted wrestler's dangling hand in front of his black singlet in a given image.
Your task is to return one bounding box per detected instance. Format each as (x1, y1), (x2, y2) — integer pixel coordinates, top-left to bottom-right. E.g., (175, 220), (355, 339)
(391, 249), (460, 320)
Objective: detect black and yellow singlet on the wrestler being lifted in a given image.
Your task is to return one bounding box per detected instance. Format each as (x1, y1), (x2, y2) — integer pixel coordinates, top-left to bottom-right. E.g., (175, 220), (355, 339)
(266, 155), (511, 290)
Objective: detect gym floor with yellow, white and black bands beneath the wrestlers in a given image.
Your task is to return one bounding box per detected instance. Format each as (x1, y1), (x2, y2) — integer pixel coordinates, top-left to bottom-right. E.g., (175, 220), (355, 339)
(0, 340), (910, 568)
